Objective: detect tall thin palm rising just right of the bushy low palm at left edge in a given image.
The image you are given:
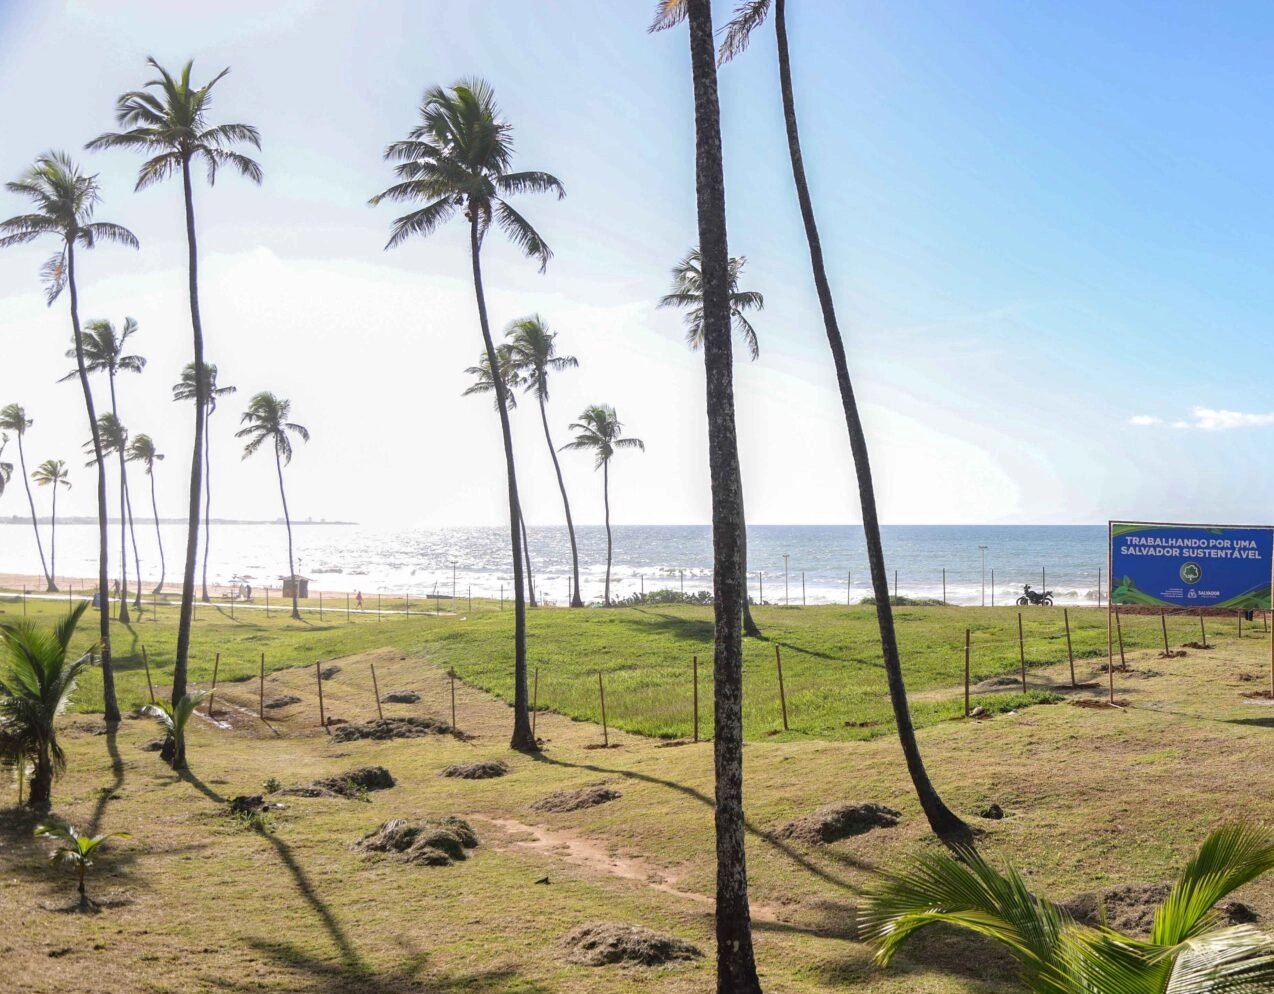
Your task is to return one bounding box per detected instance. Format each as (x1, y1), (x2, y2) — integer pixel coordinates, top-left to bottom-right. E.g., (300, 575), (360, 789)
(0, 152), (138, 724)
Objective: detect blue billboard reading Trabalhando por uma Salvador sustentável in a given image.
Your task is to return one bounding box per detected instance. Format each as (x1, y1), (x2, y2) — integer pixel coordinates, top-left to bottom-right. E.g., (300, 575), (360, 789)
(1110, 521), (1274, 610)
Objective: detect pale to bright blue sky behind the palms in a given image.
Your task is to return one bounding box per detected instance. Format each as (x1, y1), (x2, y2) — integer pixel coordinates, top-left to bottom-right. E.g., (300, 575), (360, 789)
(0, 0), (1274, 524)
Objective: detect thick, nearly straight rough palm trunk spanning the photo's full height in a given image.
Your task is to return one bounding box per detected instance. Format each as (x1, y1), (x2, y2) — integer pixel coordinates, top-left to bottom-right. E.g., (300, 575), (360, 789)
(651, 0), (761, 994)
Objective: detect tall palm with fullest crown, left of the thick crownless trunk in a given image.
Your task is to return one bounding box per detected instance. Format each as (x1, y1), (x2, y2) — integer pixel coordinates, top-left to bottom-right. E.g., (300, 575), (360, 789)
(371, 79), (566, 752)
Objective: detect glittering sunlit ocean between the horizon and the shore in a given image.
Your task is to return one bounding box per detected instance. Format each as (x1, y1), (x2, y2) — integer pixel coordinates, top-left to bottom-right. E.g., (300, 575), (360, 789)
(0, 521), (1106, 604)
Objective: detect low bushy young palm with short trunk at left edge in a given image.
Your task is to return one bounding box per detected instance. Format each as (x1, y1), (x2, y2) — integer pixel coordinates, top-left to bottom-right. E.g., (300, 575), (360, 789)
(0, 600), (92, 808)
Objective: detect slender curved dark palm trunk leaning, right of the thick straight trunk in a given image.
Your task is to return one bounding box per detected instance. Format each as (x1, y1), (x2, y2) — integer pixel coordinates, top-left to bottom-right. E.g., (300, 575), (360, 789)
(775, 0), (972, 846)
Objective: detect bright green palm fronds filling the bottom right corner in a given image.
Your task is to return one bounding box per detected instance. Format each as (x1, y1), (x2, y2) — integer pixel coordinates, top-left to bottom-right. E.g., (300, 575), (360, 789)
(859, 825), (1274, 994)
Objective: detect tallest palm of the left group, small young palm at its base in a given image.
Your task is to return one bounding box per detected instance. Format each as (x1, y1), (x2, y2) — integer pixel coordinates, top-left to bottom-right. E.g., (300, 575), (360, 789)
(88, 59), (261, 703)
